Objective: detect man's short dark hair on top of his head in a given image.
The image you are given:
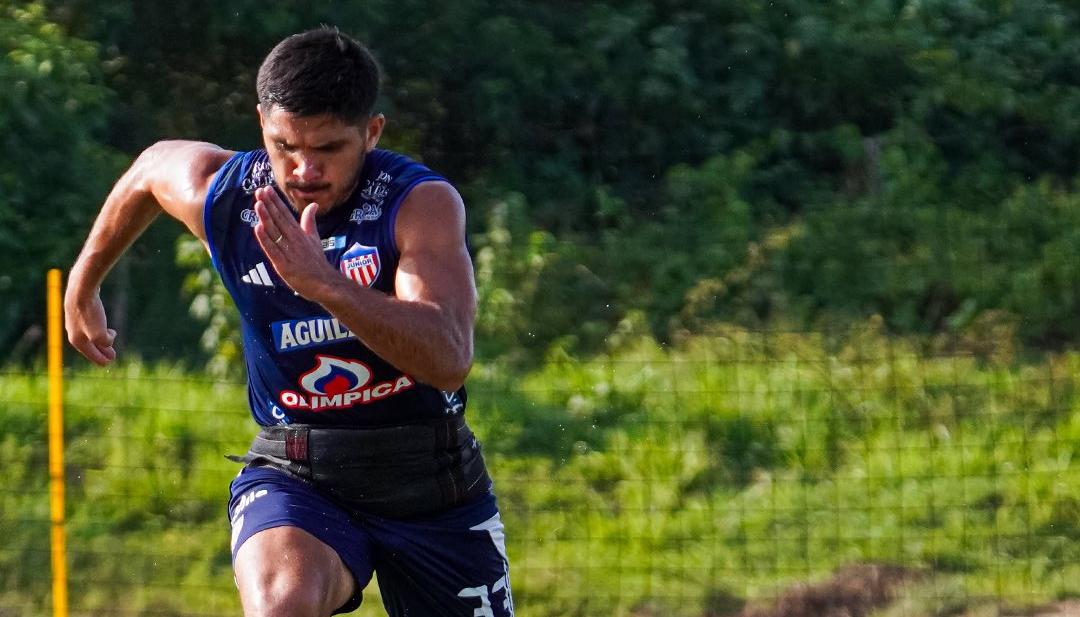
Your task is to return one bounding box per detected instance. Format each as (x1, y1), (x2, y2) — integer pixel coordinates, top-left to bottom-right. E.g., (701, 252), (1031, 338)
(255, 26), (381, 122)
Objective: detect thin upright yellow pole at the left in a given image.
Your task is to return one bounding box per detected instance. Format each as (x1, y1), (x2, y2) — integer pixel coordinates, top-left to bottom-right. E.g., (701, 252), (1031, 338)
(48, 268), (67, 617)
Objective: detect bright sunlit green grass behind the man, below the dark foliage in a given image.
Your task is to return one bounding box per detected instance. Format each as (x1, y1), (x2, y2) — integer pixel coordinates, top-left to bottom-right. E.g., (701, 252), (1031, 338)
(0, 323), (1080, 617)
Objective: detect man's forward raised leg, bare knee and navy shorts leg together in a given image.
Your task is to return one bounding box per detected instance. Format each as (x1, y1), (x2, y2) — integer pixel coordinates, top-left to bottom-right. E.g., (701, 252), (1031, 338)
(229, 467), (373, 613)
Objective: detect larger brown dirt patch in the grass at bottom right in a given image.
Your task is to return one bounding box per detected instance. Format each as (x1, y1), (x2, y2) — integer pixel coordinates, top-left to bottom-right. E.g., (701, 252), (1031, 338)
(739, 564), (921, 617)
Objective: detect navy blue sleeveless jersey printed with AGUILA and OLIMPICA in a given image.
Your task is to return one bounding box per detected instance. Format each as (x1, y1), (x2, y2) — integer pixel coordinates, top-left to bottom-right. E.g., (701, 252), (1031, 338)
(203, 150), (465, 427)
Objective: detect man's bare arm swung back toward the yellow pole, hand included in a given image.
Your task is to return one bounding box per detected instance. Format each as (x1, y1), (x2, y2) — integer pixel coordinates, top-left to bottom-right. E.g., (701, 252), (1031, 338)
(64, 142), (233, 365)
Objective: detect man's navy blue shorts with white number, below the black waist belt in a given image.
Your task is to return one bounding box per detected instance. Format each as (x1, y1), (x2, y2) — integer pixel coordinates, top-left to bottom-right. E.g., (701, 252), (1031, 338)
(229, 467), (514, 617)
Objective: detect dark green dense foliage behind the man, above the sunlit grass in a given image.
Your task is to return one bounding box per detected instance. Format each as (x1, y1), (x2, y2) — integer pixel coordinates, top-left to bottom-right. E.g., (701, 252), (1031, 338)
(0, 0), (1080, 359)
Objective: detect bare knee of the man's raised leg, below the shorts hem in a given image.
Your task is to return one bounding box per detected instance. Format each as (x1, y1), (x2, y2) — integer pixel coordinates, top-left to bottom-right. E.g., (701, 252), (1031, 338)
(233, 527), (354, 617)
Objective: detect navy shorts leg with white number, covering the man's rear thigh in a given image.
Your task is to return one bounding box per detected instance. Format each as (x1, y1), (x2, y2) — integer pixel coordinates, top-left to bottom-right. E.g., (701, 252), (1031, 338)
(364, 495), (514, 617)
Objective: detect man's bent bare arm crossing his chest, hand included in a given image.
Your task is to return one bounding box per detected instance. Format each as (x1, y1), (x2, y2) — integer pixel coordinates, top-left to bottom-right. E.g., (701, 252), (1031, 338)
(255, 182), (476, 391)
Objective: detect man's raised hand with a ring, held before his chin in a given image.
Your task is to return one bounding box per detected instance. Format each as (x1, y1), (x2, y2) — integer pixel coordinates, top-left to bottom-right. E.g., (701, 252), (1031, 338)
(255, 187), (337, 301)
